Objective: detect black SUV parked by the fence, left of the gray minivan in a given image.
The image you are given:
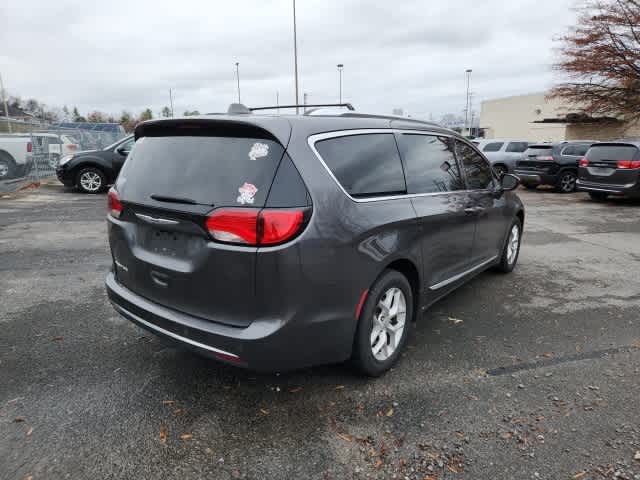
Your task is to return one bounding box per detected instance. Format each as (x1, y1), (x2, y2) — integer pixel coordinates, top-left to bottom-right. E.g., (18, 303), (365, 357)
(56, 135), (135, 193)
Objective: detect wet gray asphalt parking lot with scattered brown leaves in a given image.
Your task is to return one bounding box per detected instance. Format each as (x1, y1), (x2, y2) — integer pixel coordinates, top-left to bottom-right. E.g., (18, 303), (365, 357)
(0, 185), (640, 480)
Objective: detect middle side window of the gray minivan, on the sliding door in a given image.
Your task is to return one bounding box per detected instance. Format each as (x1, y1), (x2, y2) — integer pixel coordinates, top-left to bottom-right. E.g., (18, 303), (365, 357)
(398, 134), (464, 193)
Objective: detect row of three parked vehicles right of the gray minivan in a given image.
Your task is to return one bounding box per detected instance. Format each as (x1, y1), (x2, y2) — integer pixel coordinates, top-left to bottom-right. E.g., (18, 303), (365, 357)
(473, 139), (640, 201)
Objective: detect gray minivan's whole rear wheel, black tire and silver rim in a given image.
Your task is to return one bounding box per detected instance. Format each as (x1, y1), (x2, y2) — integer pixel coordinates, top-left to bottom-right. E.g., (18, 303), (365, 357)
(352, 270), (414, 377)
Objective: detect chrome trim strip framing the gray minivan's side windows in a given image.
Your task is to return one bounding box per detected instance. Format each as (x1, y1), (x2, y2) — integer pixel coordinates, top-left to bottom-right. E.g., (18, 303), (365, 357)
(307, 128), (492, 203)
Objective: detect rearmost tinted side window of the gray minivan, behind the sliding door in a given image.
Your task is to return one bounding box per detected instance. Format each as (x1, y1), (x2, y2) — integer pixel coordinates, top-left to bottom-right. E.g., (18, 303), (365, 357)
(315, 133), (406, 196)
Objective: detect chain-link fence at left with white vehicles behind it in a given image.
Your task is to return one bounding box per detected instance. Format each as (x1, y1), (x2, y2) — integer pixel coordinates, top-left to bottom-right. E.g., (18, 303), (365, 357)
(0, 118), (125, 194)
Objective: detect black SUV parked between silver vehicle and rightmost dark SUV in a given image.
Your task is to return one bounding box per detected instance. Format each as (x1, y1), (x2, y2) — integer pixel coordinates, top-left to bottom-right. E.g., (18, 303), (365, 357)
(514, 140), (595, 193)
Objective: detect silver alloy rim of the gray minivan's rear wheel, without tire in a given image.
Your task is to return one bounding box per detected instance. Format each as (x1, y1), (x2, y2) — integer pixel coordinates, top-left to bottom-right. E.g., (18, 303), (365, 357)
(371, 287), (407, 361)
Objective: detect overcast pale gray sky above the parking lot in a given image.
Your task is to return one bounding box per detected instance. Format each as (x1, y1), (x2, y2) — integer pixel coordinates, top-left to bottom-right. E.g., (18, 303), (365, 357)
(0, 0), (575, 118)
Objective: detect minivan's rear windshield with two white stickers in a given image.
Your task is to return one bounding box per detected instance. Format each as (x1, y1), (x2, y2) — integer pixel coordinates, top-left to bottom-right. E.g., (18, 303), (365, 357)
(118, 136), (284, 207)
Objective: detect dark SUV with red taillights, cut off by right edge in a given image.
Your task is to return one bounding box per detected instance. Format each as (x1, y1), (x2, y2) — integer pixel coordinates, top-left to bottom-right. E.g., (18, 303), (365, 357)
(578, 141), (640, 200)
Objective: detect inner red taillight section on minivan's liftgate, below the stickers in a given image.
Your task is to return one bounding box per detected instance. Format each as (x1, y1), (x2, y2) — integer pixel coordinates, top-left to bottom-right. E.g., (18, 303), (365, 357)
(207, 208), (260, 245)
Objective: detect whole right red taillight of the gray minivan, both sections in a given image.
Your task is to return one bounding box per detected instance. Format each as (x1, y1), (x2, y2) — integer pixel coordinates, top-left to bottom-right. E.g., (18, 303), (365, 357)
(206, 208), (304, 245)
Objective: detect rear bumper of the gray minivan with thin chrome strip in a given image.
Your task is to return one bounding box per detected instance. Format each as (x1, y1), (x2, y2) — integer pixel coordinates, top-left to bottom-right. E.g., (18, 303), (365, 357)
(106, 272), (355, 372)
